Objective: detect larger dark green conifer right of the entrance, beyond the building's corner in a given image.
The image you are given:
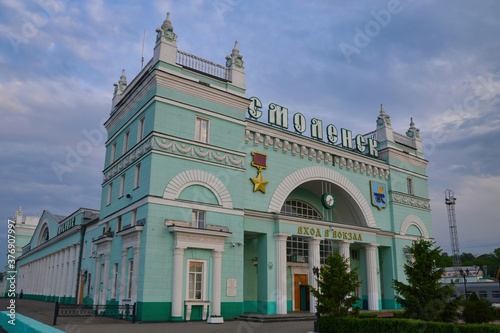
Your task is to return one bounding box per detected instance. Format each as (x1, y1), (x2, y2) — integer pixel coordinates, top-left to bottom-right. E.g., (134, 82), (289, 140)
(393, 239), (460, 321)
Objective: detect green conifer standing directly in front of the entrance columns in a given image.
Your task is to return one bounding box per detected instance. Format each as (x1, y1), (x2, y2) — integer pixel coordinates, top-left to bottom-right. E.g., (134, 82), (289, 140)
(309, 251), (361, 317)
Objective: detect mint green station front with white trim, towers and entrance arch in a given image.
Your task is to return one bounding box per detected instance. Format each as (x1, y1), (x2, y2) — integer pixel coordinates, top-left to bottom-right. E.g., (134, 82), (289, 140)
(13, 13), (432, 321)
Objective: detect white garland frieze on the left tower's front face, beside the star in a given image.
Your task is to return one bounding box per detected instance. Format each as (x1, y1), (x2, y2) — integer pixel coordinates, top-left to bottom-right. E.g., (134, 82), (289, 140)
(154, 137), (245, 169)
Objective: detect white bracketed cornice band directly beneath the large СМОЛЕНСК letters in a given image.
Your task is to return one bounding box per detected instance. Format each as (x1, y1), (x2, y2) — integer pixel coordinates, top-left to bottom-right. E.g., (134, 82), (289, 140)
(245, 129), (390, 180)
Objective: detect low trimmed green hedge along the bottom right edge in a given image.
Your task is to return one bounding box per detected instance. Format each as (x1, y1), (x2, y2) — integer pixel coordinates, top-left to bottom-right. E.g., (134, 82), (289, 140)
(319, 317), (500, 333)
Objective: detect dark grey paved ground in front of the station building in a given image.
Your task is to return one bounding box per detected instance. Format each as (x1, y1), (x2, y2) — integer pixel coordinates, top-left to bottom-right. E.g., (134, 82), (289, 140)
(0, 298), (313, 333)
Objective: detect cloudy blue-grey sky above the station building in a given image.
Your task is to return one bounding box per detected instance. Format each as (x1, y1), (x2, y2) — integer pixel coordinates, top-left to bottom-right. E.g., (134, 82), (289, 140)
(0, 0), (500, 267)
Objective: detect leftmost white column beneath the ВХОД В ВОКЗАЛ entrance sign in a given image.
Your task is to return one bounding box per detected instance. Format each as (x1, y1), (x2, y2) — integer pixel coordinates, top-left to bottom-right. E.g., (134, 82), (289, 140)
(274, 233), (290, 314)
